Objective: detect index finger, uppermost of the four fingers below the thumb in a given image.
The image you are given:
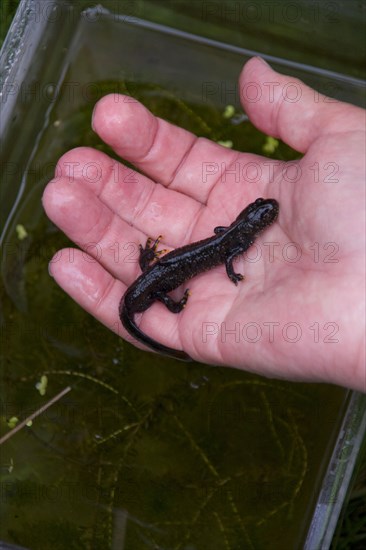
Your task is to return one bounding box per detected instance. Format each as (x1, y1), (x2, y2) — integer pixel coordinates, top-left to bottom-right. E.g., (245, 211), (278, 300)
(92, 94), (237, 203)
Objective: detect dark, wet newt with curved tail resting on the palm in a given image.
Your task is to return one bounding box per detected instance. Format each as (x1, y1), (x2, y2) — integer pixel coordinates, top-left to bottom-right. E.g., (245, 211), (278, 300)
(119, 199), (279, 361)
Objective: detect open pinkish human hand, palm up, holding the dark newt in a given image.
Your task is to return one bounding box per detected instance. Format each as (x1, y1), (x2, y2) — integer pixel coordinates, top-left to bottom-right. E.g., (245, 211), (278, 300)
(43, 58), (366, 391)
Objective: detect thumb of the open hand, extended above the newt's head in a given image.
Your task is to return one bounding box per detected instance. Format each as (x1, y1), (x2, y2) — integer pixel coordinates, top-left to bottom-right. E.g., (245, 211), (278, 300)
(240, 58), (365, 152)
